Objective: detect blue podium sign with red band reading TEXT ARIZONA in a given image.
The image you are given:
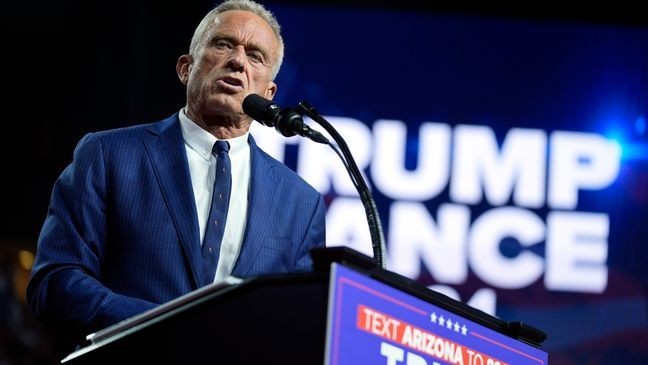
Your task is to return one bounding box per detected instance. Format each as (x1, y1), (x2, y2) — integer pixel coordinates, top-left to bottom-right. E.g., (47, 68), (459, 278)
(324, 263), (548, 365)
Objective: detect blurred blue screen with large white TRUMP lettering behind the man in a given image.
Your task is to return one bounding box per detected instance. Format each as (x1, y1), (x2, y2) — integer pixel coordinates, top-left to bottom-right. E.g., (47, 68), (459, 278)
(246, 2), (648, 365)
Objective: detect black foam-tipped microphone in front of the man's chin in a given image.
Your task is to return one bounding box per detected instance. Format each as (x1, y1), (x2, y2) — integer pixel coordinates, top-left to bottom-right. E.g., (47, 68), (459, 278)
(243, 94), (329, 144)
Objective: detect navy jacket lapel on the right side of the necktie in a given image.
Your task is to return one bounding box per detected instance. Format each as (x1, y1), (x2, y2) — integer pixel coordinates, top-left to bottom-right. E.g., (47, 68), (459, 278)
(232, 135), (279, 277)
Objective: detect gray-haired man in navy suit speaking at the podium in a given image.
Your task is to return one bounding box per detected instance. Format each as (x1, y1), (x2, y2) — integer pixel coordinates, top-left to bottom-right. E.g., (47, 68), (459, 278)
(27, 0), (325, 346)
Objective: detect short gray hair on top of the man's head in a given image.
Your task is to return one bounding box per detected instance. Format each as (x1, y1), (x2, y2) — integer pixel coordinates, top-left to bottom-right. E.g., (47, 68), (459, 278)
(189, 0), (284, 80)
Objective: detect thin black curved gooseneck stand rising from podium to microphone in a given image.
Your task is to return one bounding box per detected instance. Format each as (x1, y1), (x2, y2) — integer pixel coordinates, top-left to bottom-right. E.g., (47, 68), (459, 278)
(297, 100), (386, 269)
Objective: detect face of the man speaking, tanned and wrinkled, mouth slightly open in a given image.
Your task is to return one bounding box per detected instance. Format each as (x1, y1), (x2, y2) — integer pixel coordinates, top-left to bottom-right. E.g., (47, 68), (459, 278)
(181, 10), (279, 120)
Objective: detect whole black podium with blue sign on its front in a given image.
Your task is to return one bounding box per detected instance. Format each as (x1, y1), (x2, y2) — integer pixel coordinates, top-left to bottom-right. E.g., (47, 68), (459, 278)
(61, 247), (548, 365)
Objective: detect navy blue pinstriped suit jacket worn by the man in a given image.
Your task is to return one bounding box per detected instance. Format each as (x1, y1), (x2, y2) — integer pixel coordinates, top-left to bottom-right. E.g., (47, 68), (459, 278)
(27, 113), (325, 336)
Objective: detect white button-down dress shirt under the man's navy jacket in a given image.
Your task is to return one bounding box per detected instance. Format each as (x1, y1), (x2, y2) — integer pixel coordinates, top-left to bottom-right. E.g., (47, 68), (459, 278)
(179, 108), (250, 282)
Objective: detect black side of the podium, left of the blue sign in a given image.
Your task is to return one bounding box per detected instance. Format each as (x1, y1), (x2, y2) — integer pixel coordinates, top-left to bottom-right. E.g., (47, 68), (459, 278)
(62, 274), (328, 364)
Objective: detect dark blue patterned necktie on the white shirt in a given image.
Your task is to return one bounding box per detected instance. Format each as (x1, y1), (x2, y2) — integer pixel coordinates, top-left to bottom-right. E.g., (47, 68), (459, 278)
(202, 141), (232, 285)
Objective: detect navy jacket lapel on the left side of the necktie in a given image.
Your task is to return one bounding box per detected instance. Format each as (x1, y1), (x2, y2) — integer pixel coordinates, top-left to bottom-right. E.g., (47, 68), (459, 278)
(144, 114), (204, 288)
